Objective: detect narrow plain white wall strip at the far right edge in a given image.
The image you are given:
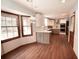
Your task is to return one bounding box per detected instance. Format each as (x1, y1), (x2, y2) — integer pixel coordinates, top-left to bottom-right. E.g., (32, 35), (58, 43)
(74, 7), (78, 57)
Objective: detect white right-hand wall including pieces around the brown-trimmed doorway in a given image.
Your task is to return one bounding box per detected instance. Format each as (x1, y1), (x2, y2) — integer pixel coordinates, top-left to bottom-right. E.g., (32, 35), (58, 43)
(69, 4), (78, 57)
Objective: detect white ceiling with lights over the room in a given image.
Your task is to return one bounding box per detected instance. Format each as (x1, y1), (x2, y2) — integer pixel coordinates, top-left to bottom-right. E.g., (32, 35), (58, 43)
(13, 0), (77, 18)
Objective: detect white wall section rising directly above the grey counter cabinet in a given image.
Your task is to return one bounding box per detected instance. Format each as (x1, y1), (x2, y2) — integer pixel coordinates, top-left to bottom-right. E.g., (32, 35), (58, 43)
(35, 13), (45, 31)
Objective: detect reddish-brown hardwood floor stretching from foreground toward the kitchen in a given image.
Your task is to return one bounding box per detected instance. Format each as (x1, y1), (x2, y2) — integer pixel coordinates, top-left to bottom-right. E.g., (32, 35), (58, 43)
(2, 35), (77, 59)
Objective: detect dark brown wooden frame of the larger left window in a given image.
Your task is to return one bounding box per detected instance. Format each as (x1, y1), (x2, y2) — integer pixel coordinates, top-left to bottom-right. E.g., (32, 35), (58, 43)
(1, 10), (20, 43)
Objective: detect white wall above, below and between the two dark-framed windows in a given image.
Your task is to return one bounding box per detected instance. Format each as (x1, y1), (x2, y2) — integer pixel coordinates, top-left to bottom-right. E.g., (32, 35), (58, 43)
(1, 0), (36, 55)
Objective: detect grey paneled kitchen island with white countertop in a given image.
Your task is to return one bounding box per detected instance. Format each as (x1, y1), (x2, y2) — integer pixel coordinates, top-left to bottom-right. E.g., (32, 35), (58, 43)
(36, 30), (51, 44)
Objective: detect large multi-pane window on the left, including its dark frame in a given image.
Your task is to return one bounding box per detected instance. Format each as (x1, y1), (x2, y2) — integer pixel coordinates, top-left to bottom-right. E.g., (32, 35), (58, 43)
(1, 12), (20, 42)
